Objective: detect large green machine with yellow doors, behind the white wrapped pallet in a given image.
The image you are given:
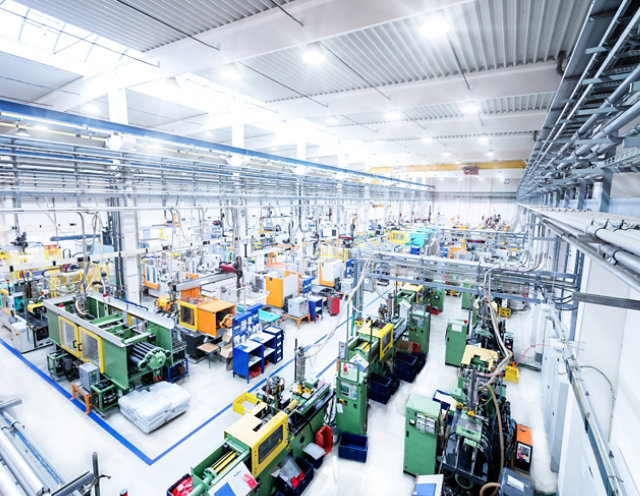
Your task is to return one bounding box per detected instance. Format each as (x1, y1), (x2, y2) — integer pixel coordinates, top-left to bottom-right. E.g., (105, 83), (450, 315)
(44, 292), (189, 413)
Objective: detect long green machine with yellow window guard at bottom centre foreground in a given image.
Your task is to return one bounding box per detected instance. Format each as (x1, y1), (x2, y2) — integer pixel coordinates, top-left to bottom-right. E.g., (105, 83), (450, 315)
(172, 366), (333, 496)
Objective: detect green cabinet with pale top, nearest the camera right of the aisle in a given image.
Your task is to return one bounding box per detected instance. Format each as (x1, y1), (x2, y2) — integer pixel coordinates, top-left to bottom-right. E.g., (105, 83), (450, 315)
(404, 394), (440, 475)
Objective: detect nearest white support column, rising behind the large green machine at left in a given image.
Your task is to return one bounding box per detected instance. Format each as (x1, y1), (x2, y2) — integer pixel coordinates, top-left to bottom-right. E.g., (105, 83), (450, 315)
(108, 88), (140, 303)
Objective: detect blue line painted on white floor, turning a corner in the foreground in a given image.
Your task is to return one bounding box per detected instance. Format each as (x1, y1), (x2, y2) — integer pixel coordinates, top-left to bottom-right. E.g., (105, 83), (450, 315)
(0, 290), (389, 465)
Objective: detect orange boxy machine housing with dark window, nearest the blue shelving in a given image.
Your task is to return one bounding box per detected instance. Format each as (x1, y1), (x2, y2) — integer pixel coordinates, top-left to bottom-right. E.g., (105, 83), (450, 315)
(178, 298), (236, 338)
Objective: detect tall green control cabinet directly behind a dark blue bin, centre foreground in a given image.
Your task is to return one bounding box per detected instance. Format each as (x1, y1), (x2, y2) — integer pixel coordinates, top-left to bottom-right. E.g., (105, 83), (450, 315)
(336, 359), (369, 436)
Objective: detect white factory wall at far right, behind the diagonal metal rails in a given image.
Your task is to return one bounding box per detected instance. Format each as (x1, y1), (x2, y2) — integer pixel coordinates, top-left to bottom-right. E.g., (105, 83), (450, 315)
(559, 259), (640, 496)
